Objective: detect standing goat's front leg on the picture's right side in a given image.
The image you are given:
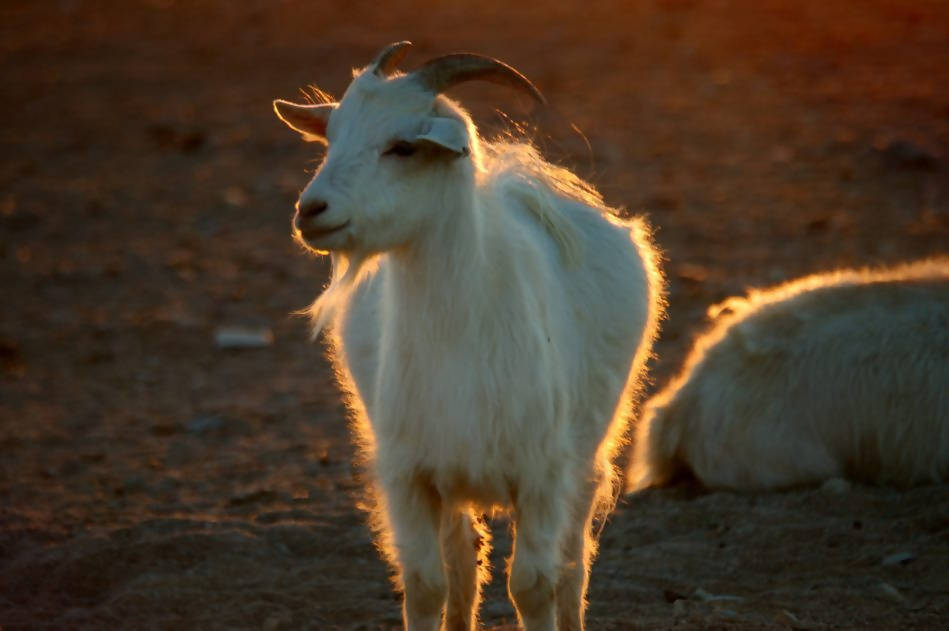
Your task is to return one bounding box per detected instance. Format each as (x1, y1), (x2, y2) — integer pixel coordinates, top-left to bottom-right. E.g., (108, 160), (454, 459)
(508, 493), (566, 631)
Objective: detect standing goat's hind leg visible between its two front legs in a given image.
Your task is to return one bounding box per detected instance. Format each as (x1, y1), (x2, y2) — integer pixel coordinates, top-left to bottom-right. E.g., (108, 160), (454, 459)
(441, 508), (490, 631)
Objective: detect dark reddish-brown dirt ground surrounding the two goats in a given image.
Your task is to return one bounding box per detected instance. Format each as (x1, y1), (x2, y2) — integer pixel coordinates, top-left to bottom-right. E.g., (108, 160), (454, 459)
(0, 0), (949, 631)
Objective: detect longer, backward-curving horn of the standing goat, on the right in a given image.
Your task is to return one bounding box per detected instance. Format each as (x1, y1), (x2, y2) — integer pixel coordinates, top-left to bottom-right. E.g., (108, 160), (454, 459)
(412, 53), (546, 104)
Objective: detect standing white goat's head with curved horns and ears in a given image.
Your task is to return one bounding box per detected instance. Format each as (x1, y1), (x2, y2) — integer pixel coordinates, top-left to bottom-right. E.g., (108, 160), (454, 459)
(274, 42), (543, 253)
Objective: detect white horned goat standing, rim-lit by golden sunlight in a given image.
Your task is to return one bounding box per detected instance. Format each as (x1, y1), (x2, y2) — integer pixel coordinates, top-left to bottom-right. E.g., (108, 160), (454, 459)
(274, 42), (662, 630)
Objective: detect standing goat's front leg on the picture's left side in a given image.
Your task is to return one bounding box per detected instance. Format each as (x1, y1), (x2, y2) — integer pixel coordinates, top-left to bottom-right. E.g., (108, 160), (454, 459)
(383, 476), (448, 631)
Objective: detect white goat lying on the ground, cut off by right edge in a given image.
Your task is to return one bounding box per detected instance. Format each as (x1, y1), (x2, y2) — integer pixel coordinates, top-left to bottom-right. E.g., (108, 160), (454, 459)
(629, 259), (949, 490)
